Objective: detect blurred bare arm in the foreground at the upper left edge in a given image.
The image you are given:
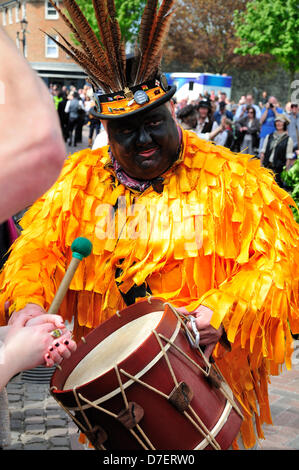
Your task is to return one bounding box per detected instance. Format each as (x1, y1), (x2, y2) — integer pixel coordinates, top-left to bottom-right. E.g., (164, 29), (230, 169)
(0, 27), (66, 222)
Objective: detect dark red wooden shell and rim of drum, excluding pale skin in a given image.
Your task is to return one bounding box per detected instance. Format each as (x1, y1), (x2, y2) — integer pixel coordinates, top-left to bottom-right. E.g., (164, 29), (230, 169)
(51, 298), (242, 450)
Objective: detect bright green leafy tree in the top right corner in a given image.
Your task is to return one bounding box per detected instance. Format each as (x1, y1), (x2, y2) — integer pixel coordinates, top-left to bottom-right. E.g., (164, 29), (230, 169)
(235, 0), (299, 81)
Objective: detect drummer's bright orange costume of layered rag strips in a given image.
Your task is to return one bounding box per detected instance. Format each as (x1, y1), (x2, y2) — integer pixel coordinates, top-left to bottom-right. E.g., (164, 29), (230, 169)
(0, 131), (299, 447)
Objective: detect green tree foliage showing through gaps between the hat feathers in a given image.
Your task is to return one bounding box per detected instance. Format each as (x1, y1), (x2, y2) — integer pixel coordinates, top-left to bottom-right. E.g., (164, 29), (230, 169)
(76, 0), (146, 43)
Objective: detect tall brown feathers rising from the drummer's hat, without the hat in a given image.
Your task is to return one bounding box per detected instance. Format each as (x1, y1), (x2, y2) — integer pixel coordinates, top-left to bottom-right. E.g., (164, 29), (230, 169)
(45, 0), (175, 93)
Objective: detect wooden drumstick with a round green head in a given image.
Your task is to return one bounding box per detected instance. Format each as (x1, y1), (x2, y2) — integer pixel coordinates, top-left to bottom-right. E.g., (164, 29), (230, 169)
(48, 237), (92, 314)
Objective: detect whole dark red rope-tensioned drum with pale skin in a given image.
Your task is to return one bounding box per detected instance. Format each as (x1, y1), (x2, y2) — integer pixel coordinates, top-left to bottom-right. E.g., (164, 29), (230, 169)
(51, 298), (242, 450)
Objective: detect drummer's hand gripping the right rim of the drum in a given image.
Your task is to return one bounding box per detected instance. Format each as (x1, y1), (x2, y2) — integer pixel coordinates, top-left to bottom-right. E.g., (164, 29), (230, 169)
(176, 305), (223, 359)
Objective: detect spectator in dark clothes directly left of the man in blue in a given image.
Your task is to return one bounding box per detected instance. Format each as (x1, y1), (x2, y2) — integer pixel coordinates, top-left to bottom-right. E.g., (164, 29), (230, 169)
(235, 106), (260, 155)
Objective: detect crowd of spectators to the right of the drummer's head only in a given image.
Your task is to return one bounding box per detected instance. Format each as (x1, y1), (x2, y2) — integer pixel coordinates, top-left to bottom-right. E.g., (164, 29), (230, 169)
(176, 92), (299, 186)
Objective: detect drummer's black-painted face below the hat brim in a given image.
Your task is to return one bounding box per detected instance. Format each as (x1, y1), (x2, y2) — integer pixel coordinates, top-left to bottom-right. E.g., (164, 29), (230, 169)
(107, 104), (179, 180)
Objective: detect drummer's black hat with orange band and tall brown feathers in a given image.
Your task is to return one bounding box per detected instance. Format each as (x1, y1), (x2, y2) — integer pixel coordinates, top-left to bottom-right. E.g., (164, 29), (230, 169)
(45, 0), (176, 119)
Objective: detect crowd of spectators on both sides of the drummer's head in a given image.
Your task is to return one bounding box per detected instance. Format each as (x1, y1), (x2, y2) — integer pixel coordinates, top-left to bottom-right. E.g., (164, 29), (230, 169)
(49, 84), (299, 187)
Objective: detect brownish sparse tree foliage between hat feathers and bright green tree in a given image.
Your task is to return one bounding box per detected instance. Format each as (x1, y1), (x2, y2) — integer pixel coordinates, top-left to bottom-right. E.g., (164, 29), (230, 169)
(164, 0), (267, 73)
